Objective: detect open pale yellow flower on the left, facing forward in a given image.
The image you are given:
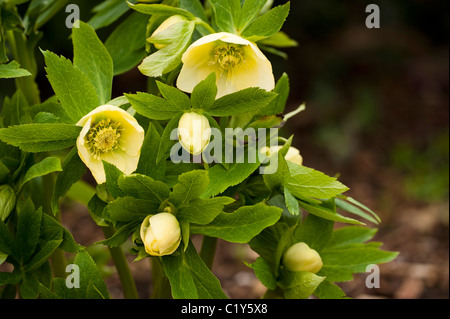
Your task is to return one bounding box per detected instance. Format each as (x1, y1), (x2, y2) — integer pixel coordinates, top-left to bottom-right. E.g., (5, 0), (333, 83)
(77, 104), (144, 184)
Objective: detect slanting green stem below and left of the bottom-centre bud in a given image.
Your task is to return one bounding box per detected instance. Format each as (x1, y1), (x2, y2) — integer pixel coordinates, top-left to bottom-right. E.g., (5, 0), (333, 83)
(102, 227), (139, 299)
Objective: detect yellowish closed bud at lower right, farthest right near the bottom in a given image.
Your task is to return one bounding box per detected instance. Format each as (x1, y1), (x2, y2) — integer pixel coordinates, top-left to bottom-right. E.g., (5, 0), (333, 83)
(283, 242), (323, 274)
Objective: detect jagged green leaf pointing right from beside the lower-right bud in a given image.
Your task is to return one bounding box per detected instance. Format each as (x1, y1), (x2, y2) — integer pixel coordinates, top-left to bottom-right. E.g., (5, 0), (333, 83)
(319, 243), (398, 282)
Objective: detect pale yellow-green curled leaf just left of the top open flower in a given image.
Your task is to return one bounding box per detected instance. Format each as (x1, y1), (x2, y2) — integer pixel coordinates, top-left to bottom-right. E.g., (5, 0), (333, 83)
(138, 20), (195, 77)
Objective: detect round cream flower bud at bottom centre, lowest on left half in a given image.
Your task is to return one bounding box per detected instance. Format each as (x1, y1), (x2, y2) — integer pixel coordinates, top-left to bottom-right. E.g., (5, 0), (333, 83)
(140, 213), (181, 256)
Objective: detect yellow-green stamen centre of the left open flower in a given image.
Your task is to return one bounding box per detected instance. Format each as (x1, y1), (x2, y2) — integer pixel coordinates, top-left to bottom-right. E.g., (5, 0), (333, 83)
(86, 119), (120, 158)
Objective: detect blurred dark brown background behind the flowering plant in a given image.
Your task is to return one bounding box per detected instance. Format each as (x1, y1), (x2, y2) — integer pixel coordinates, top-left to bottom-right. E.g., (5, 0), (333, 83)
(1, 0), (449, 298)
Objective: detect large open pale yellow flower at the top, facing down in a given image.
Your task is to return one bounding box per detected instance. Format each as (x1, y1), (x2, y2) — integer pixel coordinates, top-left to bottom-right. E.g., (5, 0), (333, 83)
(177, 32), (275, 98)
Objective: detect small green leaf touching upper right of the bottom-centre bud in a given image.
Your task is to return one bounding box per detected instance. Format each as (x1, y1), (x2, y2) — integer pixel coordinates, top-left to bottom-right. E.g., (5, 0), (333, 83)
(177, 197), (234, 225)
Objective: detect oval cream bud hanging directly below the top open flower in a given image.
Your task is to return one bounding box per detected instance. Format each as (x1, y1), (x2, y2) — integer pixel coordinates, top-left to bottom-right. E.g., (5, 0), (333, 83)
(178, 112), (211, 155)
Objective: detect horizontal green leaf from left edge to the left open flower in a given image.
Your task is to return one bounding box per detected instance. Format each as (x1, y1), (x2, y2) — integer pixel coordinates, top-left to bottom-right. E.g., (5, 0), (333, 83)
(0, 123), (81, 152)
